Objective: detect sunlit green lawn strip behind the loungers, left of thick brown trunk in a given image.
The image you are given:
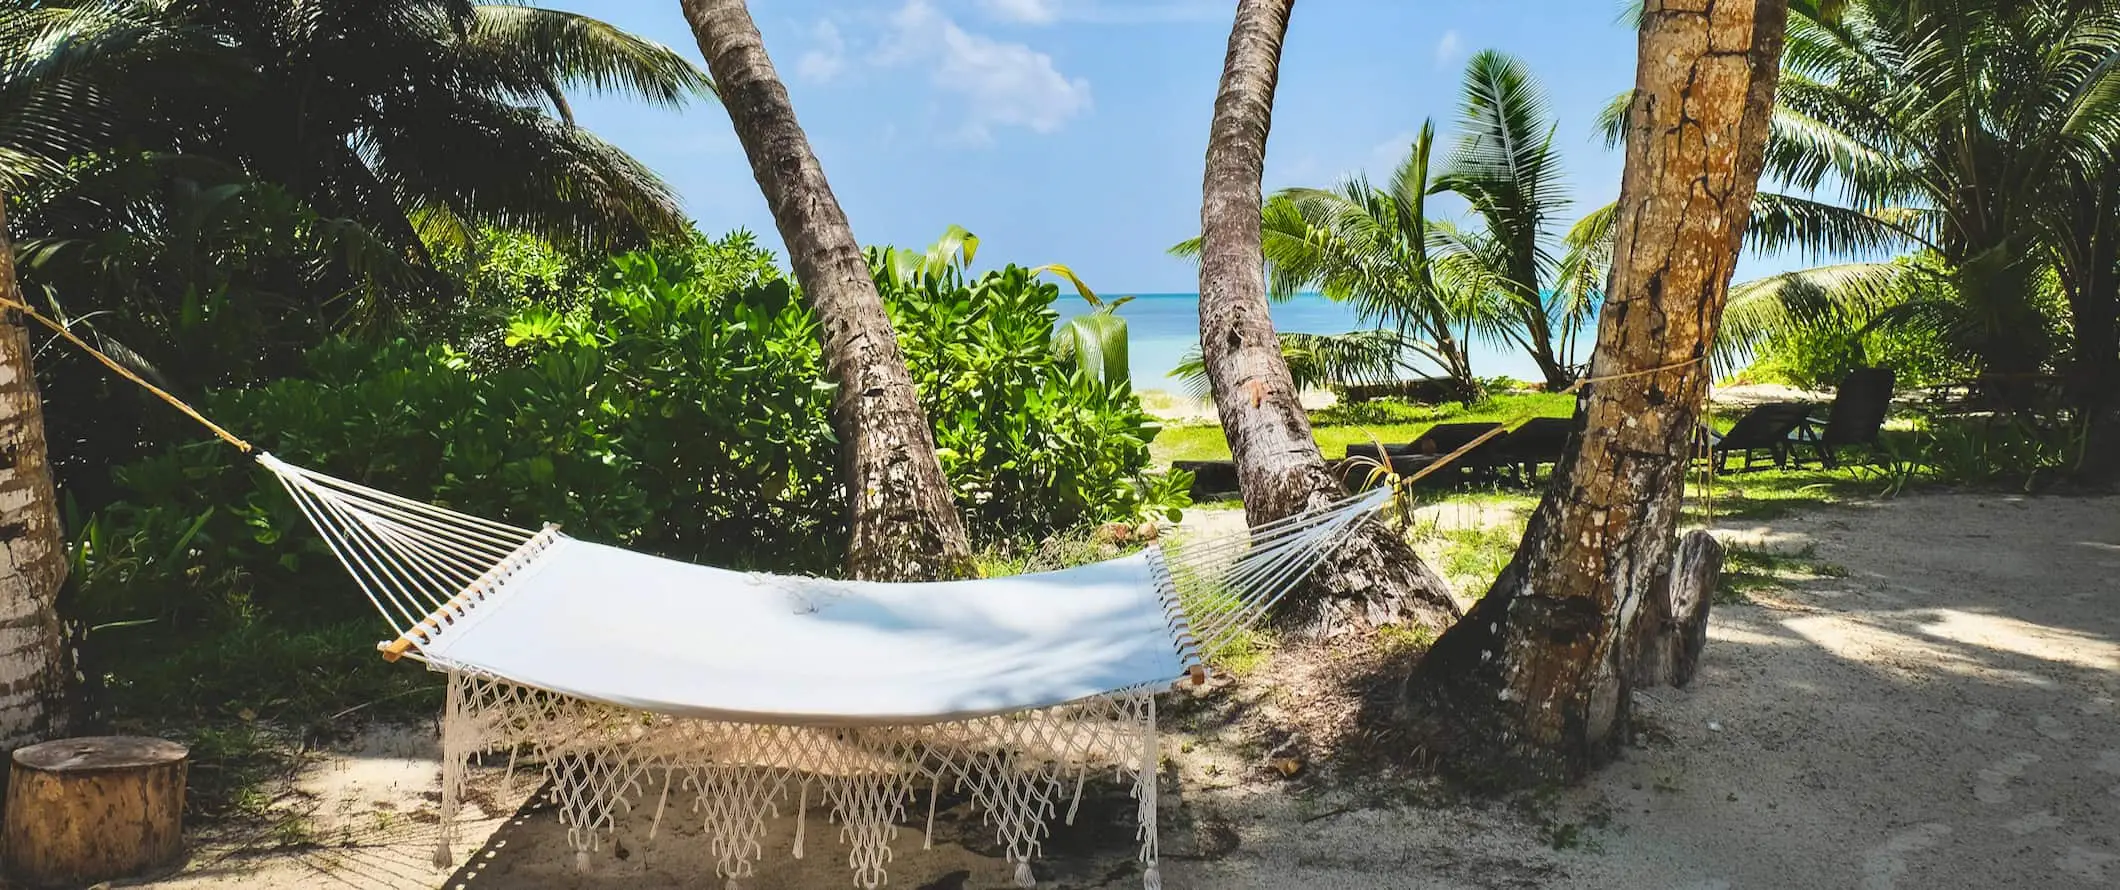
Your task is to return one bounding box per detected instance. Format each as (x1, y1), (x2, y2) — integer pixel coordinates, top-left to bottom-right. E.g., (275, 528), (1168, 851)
(1149, 392), (1575, 466)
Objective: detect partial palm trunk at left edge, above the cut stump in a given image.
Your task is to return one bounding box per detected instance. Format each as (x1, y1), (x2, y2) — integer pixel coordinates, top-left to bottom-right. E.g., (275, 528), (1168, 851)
(0, 197), (66, 750)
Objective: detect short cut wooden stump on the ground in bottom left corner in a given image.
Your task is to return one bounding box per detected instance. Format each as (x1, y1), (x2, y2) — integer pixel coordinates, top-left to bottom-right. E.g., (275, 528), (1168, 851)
(4, 735), (191, 888)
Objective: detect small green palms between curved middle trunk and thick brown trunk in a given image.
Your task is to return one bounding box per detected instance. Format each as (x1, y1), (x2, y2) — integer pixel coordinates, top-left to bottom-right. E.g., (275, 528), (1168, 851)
(1172, 51), (1611, 392)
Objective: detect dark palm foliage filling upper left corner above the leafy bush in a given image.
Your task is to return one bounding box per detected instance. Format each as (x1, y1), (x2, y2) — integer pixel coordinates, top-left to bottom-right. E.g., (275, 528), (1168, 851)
(0, 0), (710, 487)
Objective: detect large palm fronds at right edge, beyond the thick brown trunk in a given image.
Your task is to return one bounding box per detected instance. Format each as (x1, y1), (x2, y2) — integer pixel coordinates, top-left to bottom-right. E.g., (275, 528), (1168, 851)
(1704, 0), (2120, 420)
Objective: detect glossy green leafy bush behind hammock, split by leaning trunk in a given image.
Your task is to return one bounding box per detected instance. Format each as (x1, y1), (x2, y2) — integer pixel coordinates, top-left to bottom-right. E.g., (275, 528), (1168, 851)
(70, 233), (1185, 665)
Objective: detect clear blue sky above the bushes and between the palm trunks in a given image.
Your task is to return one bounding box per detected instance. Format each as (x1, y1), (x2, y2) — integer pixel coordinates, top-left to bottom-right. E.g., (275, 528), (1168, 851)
(547, 0), (1787, 292)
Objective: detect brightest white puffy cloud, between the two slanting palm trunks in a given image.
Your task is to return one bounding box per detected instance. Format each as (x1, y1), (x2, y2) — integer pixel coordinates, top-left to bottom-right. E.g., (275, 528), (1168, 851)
(873, 0), (1090, 144)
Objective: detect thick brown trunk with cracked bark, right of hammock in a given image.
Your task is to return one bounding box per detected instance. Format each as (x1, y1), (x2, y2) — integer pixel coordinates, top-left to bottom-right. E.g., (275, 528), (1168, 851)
(1406, 0), (1787, 786)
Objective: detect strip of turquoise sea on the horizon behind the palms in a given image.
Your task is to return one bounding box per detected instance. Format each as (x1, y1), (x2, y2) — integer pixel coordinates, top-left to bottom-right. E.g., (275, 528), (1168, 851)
(1054, 292), (1539, 392)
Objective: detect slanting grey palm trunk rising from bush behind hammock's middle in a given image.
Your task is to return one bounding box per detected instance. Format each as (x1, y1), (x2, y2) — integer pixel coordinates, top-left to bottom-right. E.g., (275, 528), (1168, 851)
(685, 0), (973, 581)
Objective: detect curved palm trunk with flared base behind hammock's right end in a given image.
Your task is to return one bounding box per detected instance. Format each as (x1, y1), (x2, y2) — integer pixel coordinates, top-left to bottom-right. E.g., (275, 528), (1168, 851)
(1200, 0), (1459, 636)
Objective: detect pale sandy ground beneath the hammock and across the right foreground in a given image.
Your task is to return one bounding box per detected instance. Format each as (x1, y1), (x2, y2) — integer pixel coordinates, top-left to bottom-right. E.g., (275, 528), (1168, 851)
(140, 494), (2120, 890)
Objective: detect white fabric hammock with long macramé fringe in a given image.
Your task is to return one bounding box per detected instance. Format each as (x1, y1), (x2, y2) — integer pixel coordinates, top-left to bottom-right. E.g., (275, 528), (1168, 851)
(259, 456), (1389, 890)
